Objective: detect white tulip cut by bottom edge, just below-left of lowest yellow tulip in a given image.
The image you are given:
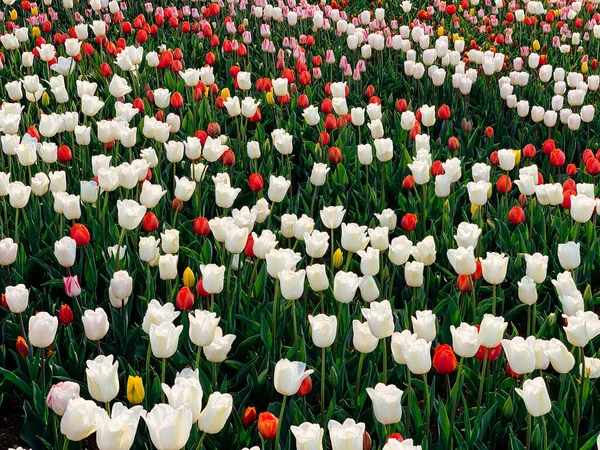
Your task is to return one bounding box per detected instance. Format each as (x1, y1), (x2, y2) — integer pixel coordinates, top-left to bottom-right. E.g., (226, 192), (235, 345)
(96, 403), (144, 450)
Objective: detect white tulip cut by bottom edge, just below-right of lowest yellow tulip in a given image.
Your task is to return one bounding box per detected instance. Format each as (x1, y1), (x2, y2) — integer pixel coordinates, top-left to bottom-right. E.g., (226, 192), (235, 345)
(143, 403), (193, 450)
